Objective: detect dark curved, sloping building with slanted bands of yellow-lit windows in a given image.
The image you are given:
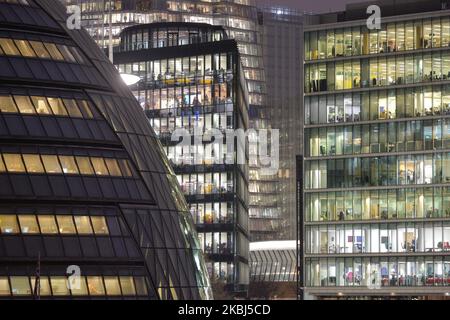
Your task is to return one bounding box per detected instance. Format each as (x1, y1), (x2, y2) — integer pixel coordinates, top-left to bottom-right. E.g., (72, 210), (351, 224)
(0, 0), (211, 299)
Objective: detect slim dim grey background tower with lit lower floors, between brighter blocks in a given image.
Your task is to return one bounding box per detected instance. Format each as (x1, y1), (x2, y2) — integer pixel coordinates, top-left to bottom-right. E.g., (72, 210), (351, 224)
(250, 6), (303, 241)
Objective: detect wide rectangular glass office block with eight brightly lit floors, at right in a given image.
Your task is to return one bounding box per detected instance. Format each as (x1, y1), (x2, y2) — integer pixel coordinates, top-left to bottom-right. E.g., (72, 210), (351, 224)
(303, 0), (450, 298)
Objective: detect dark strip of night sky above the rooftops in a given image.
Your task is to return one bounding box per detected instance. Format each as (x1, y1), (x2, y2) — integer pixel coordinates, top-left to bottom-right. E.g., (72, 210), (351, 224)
(256, 0), (367, 13)
